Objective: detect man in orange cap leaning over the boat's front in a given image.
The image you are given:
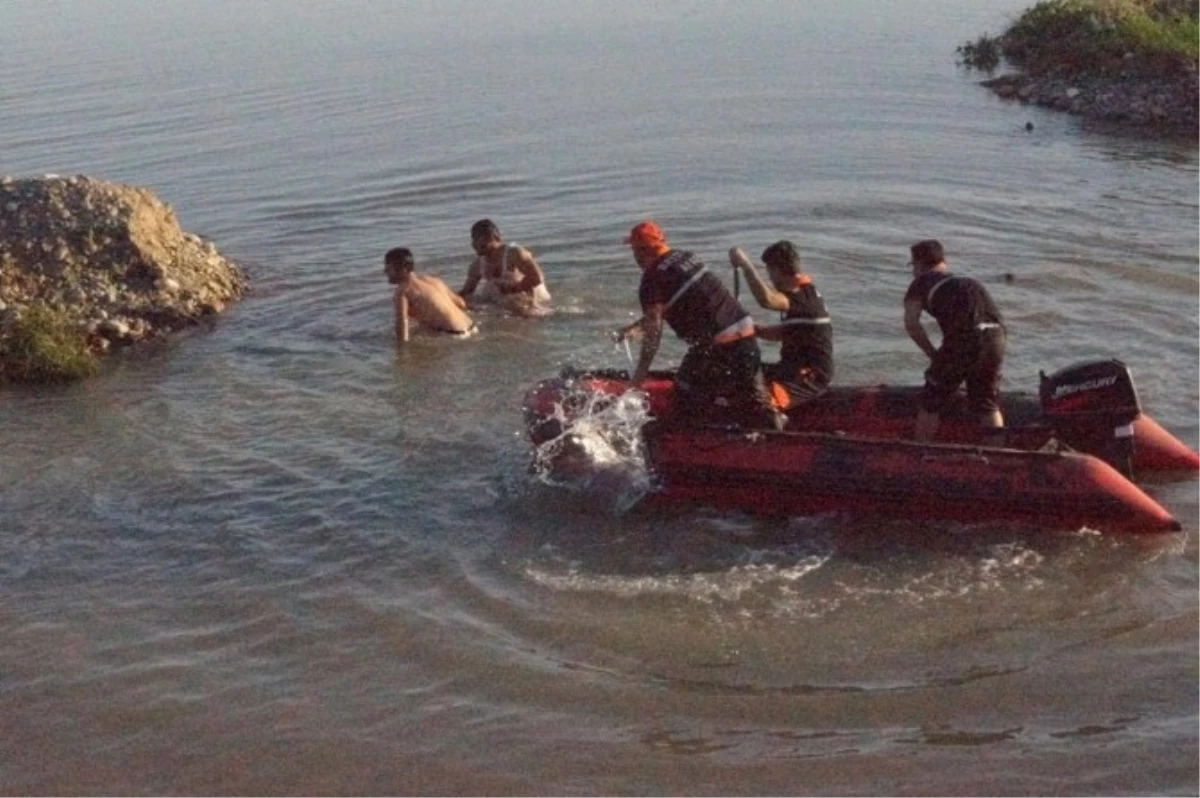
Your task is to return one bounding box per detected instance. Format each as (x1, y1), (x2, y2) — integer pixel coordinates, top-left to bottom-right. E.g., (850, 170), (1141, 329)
(617, 222), (787, 430)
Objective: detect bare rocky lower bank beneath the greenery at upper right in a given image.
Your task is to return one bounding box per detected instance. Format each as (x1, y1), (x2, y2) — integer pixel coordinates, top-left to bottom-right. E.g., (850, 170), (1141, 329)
(982, 72), (1200, 136)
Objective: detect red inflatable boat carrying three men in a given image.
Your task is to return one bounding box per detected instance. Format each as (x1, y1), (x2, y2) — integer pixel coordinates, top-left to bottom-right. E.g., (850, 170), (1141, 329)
(524, 360), (1200, 532)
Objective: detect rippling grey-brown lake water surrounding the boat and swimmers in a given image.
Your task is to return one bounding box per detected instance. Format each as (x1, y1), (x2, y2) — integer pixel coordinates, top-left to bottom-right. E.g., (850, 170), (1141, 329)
(0, 0), (1200, 796)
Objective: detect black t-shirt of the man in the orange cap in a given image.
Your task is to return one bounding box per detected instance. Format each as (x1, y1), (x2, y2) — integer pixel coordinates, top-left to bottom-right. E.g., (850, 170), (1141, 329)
(637, 250), (750, 344)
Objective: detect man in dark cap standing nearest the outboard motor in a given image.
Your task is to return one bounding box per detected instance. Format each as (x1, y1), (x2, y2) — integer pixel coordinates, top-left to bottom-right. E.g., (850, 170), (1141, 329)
(904, 239), (1006, 445)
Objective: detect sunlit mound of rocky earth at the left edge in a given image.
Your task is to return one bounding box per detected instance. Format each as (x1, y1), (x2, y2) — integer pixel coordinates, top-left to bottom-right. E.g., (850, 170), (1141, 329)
(0, 175), (247, 353)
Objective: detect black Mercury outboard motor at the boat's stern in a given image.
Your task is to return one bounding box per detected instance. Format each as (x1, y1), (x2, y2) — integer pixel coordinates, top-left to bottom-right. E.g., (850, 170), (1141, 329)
(1038, 360), (1141, 479)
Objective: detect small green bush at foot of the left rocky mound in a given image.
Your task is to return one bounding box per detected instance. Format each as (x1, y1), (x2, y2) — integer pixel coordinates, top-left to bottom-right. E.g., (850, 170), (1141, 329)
(0, 304), (100, 384)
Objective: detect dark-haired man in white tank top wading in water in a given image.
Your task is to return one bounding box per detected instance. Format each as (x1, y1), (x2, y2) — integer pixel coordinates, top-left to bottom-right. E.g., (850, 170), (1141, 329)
(458, 218), (550, 316)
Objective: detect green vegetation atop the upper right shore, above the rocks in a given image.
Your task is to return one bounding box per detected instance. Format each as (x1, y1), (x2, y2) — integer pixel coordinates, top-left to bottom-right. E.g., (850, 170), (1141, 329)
(958, 0), (1200, 76)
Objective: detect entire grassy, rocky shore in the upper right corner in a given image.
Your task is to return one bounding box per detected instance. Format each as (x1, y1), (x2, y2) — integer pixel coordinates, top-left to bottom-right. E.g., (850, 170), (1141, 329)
(958, 0), (1200, 136)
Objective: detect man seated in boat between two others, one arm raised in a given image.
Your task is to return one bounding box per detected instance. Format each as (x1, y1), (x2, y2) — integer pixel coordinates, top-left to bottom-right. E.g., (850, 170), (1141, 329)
(730, 239), (833, 409)
